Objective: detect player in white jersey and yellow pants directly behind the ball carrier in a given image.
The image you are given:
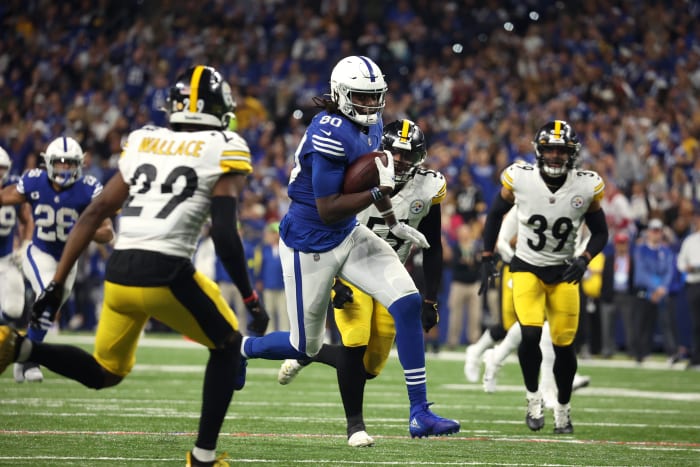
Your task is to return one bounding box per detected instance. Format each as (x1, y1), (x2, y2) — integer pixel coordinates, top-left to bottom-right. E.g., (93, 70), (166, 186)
(277, 119), (456, 447)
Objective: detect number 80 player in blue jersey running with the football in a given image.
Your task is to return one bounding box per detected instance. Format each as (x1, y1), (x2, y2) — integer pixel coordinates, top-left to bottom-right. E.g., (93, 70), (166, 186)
(241, 56), (459, 437)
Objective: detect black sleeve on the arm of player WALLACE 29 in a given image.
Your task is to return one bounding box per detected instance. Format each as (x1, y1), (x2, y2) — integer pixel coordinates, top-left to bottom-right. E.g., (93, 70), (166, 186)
(211, 196), (253, 298)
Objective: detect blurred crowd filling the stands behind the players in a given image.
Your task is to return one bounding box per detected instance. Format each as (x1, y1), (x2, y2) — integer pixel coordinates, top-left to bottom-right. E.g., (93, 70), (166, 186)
(0, 0), (700, 360)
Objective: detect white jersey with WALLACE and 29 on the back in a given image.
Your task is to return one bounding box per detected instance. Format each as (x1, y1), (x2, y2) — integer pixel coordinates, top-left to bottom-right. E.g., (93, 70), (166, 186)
(115, 127), (253, 258)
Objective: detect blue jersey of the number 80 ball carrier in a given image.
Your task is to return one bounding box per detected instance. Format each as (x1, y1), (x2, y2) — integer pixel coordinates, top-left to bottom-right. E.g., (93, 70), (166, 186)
(280, 111), (383, 252)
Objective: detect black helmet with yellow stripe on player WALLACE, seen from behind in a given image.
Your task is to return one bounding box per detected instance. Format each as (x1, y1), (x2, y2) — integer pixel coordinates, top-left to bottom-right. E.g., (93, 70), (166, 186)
(167, 65), (236, 129)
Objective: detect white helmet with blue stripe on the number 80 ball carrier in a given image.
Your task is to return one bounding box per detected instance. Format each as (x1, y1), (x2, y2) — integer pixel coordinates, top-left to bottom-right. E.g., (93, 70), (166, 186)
(331, 56), (387, 126)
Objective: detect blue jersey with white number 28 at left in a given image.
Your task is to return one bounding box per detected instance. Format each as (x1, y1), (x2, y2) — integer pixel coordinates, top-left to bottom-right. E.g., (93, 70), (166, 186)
(17, 169), (102, 260)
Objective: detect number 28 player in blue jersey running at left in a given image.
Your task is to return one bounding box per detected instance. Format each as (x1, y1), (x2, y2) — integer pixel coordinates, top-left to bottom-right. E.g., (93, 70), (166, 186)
(0, 136), (114, 383)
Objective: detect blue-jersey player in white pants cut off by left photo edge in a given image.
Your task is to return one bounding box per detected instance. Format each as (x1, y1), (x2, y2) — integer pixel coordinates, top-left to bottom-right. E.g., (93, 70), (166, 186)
(0, 148), (33, 324)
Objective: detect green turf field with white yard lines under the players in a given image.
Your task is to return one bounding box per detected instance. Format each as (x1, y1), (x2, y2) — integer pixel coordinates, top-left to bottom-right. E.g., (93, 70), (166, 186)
(0, 335), (700, 466)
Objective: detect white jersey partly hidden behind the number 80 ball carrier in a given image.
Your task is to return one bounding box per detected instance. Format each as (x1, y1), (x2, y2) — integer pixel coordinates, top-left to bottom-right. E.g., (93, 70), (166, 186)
(357, 168), (447, 263)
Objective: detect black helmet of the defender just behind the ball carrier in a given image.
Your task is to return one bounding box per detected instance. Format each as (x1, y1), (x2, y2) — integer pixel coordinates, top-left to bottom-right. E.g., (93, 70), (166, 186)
(382, 119), (428, 185)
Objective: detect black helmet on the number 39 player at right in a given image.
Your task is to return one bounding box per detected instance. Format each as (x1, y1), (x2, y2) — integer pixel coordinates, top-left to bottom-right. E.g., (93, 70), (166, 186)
(532, 120), (581, 177)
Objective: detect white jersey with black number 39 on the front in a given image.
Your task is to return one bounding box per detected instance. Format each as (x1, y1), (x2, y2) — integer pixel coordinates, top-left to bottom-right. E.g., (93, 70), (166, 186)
(501, 164), (605, 266)
